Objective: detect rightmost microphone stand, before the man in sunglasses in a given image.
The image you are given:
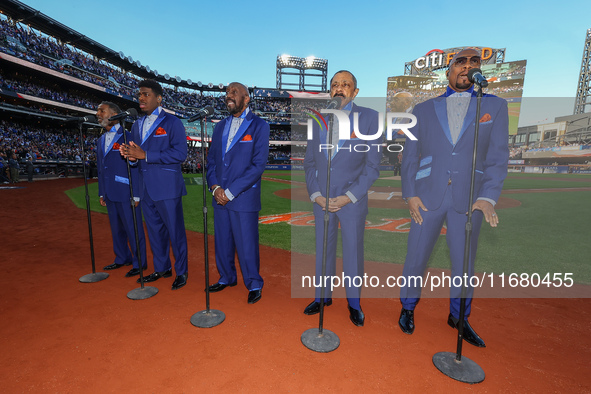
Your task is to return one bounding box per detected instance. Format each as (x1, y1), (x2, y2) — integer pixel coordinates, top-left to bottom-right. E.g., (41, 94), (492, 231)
(433, 86), (484, 384)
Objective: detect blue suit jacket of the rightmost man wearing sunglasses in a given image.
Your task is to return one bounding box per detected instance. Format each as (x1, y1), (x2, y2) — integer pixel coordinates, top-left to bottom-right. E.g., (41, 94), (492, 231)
(401, 93), (509, 213)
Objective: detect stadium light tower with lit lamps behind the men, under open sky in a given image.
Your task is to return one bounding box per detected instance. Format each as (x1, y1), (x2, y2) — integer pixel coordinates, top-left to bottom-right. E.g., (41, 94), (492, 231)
(277, 54), (328, 92)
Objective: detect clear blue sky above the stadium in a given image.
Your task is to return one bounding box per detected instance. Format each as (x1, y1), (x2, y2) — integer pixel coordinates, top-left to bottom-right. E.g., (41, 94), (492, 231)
(8, 0), (591, 121)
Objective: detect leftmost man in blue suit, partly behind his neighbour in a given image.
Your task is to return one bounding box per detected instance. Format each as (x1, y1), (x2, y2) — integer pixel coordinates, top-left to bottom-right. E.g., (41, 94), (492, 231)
(96, 101), (148, 278)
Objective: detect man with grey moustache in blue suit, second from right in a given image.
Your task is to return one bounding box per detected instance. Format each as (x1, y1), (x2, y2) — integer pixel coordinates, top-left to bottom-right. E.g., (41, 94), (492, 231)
(304, 70), (382, 326)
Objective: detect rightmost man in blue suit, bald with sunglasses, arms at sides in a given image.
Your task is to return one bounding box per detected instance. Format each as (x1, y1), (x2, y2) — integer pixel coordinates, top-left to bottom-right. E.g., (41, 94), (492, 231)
(398, 49), (509, 347)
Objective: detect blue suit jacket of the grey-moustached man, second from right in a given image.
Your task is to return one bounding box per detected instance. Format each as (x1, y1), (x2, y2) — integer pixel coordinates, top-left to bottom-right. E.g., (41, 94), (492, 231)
(304, 103), (382, 213)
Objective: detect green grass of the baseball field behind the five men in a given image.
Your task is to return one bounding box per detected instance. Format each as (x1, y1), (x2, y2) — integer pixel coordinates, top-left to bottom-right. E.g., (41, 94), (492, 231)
(66, 171), (591, 284)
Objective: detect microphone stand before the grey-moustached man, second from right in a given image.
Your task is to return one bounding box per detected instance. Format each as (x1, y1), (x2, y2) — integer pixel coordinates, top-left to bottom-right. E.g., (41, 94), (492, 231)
(301, 115), (341, 353)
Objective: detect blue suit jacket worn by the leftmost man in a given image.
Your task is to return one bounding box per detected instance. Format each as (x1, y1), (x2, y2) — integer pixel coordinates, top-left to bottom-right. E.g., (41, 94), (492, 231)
(96, 131), (139, 202)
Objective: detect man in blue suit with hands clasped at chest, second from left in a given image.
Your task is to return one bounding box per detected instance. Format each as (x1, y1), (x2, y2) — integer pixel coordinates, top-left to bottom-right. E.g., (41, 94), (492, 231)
(122, 79), (188, 290)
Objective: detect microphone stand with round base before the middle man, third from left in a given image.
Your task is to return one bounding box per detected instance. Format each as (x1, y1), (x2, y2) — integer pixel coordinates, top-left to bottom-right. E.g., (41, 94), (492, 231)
(191, 118), (226, 328)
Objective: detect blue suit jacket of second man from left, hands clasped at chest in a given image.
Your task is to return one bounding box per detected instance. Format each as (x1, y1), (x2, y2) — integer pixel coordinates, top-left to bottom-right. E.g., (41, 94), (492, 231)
(131, 110), (187, 201)
